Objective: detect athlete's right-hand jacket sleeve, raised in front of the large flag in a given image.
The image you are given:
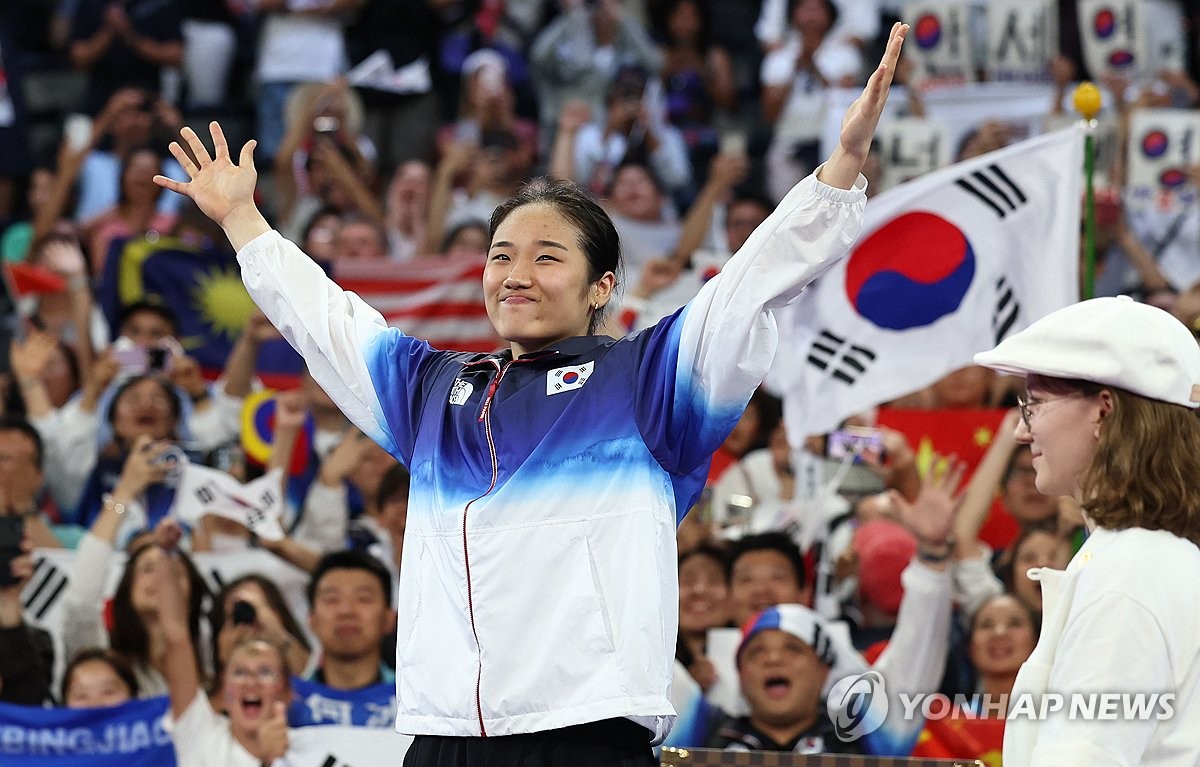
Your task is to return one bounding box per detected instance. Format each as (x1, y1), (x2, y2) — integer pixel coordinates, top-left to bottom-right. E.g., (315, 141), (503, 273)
(635, 170), (866, 474)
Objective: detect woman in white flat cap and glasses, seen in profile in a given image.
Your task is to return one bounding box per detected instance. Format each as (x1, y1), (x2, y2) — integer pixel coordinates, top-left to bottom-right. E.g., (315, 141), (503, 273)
(976, 296), (1200, 767)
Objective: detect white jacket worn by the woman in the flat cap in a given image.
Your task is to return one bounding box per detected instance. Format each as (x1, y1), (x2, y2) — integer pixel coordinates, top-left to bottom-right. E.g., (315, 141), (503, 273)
(1004, 528), (1200, 767)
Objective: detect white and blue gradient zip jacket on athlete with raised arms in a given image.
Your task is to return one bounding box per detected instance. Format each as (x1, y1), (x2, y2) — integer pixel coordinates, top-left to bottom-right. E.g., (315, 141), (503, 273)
(238, 169), (865, 742)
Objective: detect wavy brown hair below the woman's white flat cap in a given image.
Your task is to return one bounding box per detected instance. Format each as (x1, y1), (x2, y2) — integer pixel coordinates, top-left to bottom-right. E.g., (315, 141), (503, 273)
(1081, 388), (1200, 546)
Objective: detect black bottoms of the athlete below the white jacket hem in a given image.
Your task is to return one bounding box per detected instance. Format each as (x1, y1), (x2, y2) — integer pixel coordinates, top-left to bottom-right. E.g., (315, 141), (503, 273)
(404, 719), (658, 767)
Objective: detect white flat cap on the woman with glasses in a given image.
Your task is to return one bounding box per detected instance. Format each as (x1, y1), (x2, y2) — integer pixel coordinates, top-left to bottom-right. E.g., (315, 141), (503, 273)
(974, 295), (1200, 408)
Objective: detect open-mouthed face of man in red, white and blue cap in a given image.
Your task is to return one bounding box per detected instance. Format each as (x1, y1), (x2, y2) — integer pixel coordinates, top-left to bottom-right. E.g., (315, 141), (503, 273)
(738, 629), (829, 729)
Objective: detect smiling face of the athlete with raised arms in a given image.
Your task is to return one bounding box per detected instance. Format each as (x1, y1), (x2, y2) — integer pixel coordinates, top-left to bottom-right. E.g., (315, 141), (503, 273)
(484, 204), (616, 356)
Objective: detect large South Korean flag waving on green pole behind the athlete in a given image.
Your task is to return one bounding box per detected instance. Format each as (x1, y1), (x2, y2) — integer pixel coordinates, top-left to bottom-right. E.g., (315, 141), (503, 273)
(768, 126), (1084, 436)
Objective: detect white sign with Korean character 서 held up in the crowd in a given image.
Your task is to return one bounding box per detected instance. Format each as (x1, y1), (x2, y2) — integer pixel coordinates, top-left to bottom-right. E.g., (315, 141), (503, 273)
(988, 0), (1058, 83)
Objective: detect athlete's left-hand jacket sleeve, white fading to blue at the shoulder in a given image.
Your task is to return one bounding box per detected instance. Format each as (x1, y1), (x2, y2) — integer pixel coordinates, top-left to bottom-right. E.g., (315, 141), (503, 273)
(238, 232), (448, 463)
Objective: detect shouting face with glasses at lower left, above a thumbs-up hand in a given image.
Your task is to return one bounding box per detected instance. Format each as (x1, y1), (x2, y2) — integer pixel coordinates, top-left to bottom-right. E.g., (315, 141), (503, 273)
(221, 640), (290, 736)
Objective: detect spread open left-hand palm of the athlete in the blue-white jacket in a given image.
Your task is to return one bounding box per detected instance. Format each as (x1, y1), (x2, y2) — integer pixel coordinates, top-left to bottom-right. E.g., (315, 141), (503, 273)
(154, 121), (258, 226)
